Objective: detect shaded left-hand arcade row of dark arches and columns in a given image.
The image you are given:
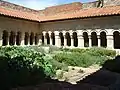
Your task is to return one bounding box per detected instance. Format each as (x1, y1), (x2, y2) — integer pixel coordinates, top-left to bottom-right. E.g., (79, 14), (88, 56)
(1, 30), (39, 46)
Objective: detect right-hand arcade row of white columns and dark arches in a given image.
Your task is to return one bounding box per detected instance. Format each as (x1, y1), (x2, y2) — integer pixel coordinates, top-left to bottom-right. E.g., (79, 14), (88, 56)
(42, 30), (120, 49)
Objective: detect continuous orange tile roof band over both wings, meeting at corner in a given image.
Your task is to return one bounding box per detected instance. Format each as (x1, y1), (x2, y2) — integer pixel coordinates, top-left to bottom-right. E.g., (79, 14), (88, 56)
(0, 6), (120, 22)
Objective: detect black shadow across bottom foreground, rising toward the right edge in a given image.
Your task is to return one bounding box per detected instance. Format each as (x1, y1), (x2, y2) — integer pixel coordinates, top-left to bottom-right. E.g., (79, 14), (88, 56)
(12, 56), (120, 90)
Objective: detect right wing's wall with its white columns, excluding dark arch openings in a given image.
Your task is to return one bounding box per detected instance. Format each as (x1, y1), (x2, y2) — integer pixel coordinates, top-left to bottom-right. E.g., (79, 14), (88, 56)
(40, 16), (120, 49)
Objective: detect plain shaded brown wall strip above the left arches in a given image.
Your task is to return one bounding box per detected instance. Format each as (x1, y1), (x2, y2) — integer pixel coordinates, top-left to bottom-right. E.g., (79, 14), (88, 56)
(0, 16), (40, 32)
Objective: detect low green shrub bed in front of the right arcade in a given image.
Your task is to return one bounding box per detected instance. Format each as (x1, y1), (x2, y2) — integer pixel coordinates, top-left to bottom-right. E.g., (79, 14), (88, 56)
(53, 47), (116, 67)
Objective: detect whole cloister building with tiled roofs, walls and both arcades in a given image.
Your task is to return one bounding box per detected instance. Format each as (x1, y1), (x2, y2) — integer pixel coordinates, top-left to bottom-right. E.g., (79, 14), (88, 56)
(0, 0), (120, 49)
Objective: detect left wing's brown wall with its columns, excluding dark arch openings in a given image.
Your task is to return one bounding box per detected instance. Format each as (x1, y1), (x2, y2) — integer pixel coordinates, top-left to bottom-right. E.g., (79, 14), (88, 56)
(0, 16), (42, 46)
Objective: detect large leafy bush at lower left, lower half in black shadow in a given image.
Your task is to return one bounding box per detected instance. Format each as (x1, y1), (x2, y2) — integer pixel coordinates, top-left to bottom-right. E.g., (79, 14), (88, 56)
(0, 47), (55, 90)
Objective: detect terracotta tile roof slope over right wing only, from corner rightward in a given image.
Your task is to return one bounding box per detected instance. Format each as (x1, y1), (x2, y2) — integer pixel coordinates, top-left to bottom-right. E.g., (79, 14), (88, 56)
(40, 6), (120, 21)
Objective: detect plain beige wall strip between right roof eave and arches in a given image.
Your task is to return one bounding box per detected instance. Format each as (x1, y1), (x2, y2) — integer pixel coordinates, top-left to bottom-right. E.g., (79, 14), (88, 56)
(40, 16), (120, 31)
